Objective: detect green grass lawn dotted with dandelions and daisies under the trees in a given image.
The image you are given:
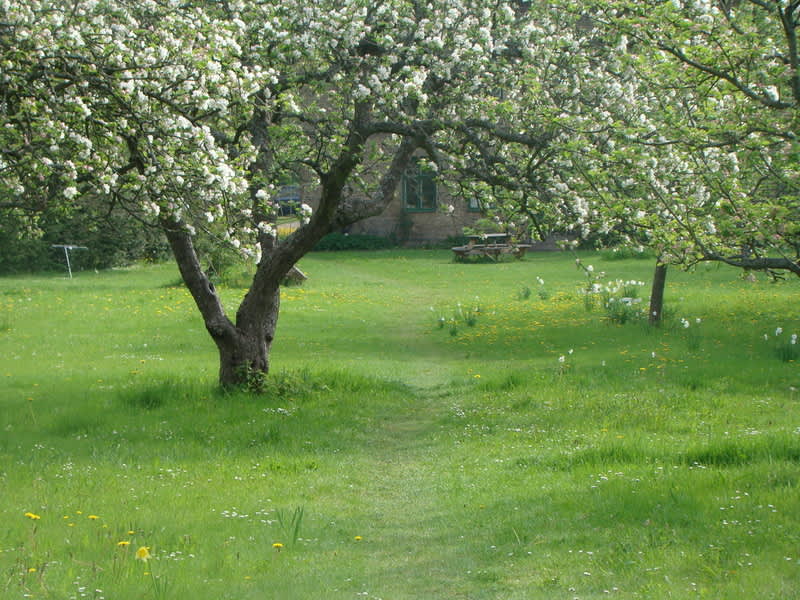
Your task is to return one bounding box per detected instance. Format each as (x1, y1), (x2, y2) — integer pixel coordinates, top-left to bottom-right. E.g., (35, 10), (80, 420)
(0, 251), (800, 600)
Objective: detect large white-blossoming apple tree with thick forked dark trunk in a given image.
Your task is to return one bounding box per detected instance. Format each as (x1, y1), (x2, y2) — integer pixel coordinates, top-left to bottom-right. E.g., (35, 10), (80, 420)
(0, 0), (564, 385)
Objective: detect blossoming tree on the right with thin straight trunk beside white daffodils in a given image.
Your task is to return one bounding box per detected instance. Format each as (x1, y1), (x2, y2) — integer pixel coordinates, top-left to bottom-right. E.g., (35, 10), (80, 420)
(444, 0), (800, 319)
